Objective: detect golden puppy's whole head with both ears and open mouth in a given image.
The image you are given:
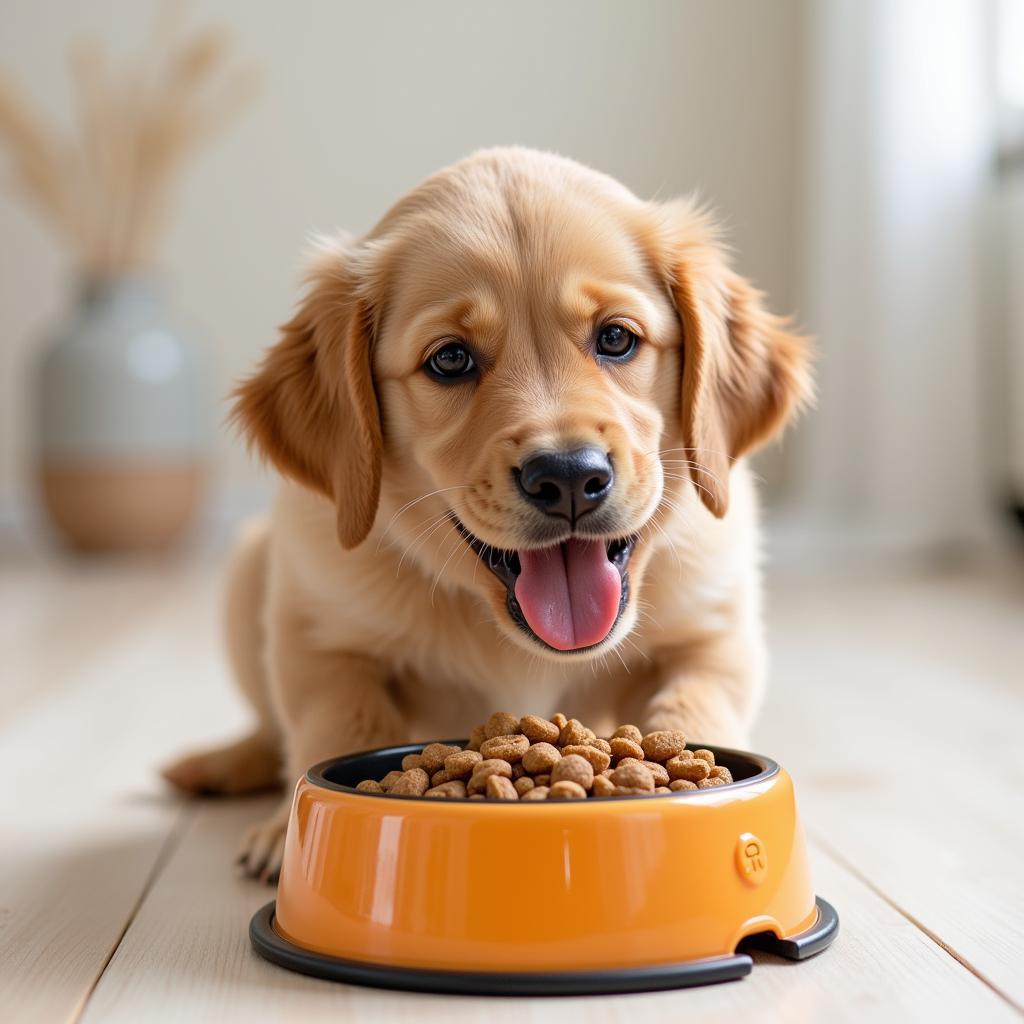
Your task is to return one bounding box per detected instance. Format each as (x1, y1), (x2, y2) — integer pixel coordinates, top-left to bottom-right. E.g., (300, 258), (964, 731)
(236, 150), (809, 656)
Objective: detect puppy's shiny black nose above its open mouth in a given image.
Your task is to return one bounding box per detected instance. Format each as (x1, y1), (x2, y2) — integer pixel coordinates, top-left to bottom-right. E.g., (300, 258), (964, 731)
(516, 447), (614, 525)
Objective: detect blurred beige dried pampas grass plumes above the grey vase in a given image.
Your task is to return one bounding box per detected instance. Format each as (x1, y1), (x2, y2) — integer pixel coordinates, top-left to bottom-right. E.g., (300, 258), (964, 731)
(0, 3), (257, 276)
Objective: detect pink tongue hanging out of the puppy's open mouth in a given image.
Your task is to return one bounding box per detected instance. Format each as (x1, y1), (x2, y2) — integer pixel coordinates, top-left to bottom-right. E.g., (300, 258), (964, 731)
(515, 538), (623, 650)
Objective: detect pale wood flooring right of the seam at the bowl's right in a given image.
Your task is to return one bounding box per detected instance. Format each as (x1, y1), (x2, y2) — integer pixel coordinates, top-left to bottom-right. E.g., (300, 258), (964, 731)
(759, 575), (1024, 1007)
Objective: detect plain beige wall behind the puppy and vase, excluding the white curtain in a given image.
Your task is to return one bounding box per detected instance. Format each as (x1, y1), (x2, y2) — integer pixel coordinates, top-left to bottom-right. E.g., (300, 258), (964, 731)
(0, 0), (803, 517)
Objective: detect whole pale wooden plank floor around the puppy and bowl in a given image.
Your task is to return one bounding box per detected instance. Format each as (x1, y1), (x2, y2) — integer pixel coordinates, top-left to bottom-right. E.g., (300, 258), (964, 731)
(0, 557), (1024, 1024)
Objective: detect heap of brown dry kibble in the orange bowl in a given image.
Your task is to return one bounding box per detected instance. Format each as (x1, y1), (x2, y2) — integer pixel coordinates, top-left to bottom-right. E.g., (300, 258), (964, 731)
(356, 711), (732, 801)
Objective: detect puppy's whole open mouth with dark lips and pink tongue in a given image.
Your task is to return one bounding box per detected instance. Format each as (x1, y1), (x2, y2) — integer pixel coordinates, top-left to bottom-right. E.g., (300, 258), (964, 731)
(453, 513), (637, 651)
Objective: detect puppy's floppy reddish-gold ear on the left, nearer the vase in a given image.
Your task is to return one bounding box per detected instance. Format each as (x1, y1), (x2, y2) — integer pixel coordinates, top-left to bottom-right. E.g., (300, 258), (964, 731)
(231, 240), (383, 548)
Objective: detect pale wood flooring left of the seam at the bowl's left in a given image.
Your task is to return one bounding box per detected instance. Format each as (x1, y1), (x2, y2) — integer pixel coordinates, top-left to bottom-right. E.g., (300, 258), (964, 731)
(0, 572), (240, 1022)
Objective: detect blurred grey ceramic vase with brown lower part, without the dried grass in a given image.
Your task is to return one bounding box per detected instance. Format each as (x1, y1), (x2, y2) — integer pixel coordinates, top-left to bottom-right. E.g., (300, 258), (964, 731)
(37, 274), (205, 551)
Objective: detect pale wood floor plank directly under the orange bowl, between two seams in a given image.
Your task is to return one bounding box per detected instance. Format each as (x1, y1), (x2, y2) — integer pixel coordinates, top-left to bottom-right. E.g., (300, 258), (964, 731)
(83, 803), (1018, 1024)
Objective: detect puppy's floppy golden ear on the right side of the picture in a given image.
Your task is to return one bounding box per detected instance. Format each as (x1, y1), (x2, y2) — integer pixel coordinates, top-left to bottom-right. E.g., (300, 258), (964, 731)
(663, 206), (812, 518)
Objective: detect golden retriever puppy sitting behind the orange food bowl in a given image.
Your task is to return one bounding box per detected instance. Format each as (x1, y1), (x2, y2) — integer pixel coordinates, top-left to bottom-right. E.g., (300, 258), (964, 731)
(166, 148), (810, 878)
